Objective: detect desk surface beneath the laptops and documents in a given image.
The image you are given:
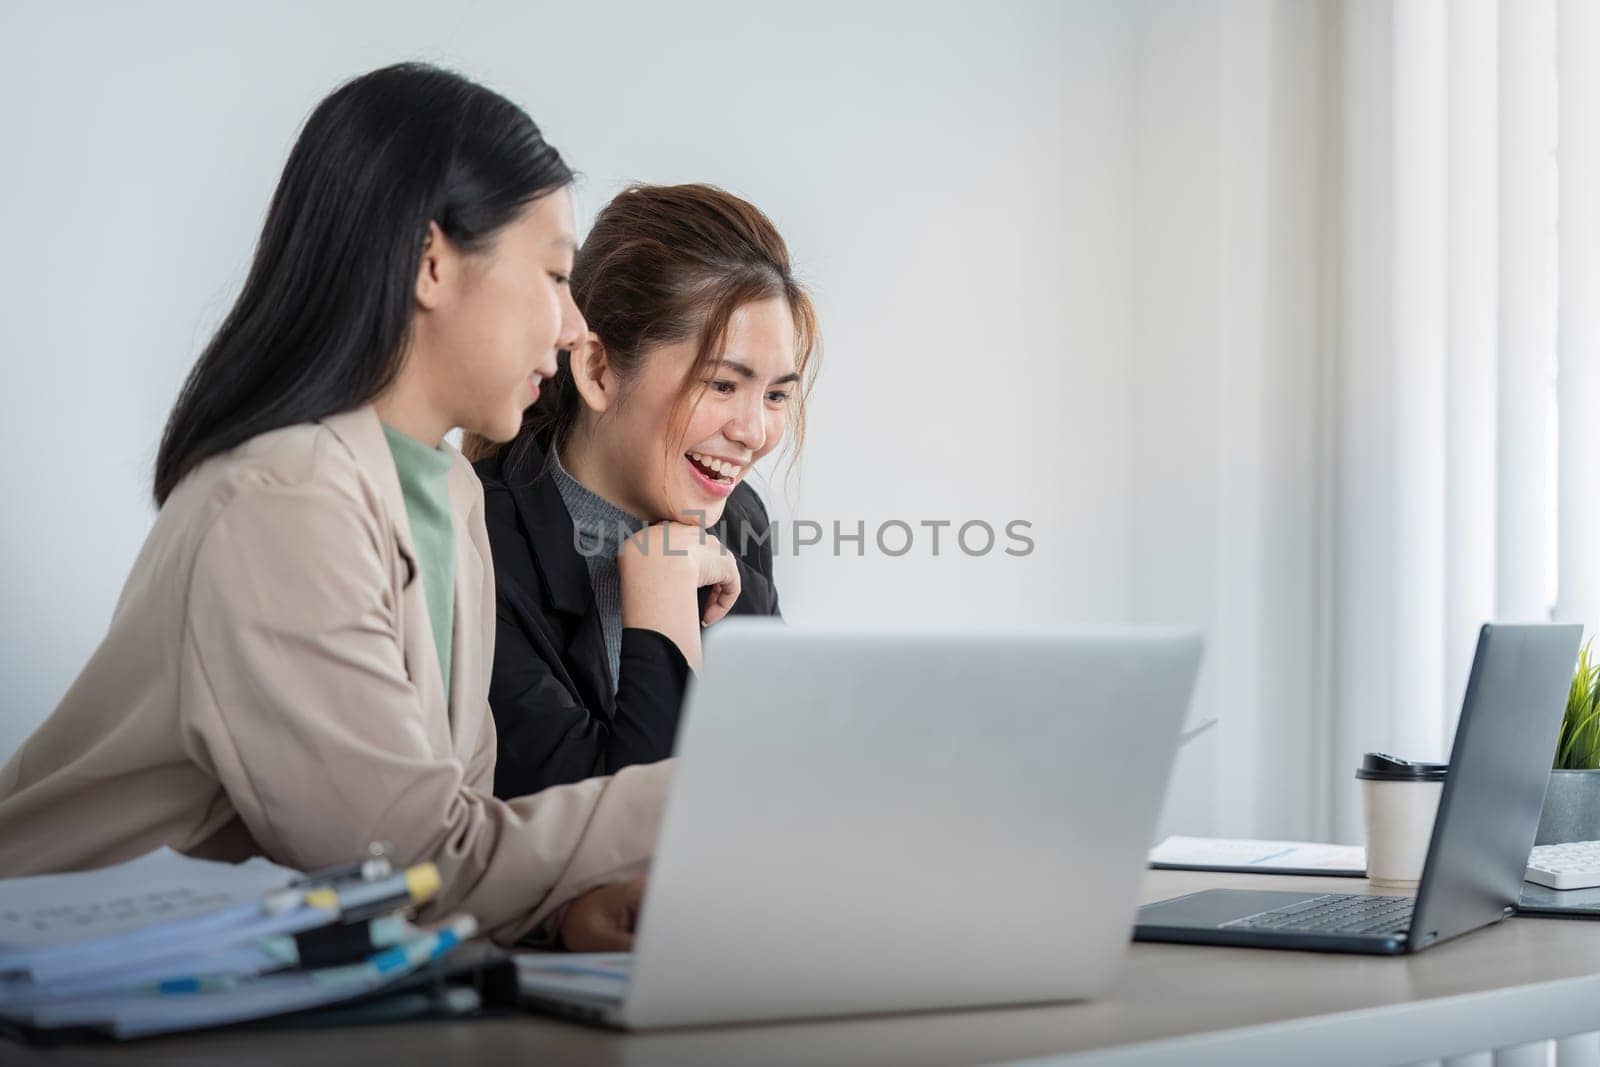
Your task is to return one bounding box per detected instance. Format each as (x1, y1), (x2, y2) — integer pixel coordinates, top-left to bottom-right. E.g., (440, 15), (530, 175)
(12, 870), (1600, 1067)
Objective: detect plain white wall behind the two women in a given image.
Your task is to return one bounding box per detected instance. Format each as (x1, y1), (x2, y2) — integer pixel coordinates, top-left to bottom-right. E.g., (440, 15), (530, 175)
(0, 0), (1152, 764)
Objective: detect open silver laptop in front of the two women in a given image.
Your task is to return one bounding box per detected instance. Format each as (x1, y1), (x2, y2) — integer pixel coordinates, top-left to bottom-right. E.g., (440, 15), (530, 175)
(518, 619), (1200, 1029)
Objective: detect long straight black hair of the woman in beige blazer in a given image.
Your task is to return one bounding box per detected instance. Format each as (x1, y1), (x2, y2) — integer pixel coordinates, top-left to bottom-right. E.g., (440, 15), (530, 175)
(155, 62), (573, 506)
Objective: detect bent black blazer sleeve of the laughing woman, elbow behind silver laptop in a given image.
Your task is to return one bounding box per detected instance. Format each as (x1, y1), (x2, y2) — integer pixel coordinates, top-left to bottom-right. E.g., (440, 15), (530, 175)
(485, 493), (690, 797)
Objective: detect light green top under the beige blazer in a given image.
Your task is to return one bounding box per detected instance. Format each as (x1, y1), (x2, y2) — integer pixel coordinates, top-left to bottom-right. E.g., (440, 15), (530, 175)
(384, 426), (456, 705)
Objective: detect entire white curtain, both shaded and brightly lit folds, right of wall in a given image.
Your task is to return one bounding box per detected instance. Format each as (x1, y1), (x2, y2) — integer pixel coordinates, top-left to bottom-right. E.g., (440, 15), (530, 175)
(1130, 0), (1600, 841)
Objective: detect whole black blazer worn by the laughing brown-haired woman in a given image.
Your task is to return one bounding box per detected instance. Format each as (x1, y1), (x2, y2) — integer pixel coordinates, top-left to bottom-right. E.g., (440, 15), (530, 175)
(477, 435), (778, 797)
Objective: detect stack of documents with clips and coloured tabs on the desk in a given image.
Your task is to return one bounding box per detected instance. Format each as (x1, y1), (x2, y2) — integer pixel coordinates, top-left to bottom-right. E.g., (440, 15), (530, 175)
(0, 849), (475, 1037)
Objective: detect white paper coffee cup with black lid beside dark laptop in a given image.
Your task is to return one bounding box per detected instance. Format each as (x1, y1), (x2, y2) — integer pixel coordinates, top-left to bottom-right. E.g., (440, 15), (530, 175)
(1355, 752), (1450, 889)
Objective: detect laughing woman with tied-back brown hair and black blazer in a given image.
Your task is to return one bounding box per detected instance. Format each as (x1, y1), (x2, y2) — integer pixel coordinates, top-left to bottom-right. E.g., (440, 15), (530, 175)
(469, 186), (816, 797)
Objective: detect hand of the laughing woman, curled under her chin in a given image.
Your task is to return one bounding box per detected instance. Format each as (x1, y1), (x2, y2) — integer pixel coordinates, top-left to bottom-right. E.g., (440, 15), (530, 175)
(616, 522), (739, 670)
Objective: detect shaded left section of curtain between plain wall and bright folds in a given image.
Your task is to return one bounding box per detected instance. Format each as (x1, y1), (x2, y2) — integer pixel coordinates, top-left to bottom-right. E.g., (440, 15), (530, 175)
(1128, 0), (1331, 837)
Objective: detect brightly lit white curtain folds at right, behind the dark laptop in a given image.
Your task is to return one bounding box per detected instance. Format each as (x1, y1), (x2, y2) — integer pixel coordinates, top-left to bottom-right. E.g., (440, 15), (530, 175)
(1328, 0), (1600, 840)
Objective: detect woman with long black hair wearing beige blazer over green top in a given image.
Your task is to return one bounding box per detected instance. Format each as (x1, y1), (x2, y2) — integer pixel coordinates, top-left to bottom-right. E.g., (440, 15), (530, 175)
(0, 64), (688, 949)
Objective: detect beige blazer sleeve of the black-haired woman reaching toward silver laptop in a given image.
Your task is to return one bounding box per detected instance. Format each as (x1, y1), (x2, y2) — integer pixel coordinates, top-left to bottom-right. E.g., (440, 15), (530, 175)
(181, 483), (670, 944)
